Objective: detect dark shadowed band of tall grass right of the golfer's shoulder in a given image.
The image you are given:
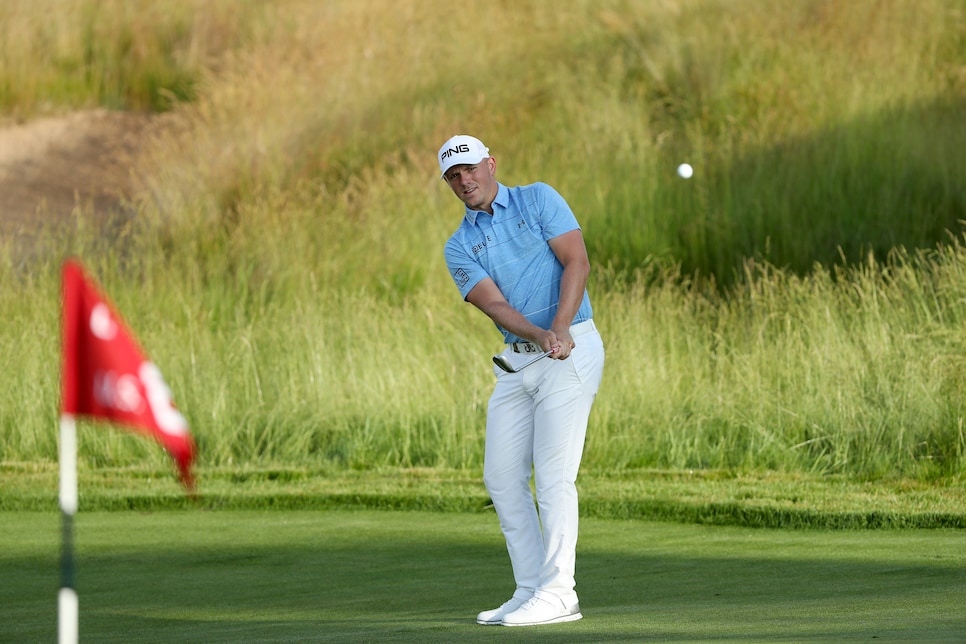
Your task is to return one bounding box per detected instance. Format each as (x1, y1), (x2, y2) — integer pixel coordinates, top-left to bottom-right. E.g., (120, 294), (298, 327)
(587, 98), (966, 286)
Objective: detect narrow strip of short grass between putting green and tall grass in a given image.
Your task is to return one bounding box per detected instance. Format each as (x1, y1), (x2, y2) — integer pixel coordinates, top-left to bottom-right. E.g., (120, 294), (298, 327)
(0, 464), (966, 530)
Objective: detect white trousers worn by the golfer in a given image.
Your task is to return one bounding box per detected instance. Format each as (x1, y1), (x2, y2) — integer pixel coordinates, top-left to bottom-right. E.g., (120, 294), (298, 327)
(483, 320), (604, 606)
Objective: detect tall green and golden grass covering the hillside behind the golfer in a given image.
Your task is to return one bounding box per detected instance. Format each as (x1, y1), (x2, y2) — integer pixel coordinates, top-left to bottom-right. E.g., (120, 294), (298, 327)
(0, 0), (966, 479)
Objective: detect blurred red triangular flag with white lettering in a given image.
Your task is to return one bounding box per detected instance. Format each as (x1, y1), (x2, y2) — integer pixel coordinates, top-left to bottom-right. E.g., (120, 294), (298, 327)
(61, 260), (194, 490)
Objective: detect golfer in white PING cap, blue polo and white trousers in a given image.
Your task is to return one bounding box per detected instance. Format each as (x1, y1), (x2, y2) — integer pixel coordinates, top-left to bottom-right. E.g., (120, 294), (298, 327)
(437, 135), (604, 626)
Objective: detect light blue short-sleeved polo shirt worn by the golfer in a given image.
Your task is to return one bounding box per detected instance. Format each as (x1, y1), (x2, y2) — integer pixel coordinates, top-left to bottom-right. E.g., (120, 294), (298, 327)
(443, 183), (594, 343)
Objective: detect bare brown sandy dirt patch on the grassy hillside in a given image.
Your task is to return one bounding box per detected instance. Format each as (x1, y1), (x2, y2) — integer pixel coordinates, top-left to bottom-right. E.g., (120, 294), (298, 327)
(0, 110), (151, 256)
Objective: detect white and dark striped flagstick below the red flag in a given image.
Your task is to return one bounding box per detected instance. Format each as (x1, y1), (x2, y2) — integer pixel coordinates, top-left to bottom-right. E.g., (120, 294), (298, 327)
(57, 414), (79, 644)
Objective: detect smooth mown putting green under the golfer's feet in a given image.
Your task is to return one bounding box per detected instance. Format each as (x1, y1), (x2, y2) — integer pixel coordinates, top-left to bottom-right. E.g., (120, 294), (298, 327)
(0, 510), (966, 642)
